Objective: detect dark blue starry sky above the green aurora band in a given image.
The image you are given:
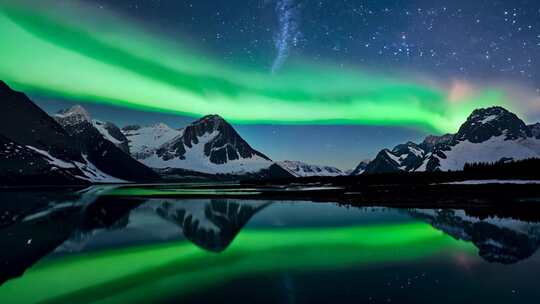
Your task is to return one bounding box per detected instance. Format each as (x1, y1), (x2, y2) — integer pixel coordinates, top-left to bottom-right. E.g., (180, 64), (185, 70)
(85, 0), (540, 84)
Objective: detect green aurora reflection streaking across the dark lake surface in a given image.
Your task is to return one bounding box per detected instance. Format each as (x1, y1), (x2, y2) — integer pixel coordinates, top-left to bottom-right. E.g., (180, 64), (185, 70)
(0, 222), (475, 304)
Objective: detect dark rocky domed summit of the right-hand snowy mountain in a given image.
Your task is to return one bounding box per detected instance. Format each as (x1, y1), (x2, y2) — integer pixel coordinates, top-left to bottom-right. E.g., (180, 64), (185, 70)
(454, 106), (531, 143)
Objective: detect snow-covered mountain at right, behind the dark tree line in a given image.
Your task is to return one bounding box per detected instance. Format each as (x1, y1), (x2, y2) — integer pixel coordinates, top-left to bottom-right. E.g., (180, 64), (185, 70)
(354, 107), (540, 173)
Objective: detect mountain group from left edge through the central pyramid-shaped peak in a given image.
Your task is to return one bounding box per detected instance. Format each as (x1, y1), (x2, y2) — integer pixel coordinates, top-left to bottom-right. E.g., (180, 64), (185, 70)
(0, 82), (293, 185)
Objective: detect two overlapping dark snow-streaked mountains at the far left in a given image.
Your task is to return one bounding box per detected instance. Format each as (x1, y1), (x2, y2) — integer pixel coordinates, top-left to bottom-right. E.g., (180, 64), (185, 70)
(0, 82), (159, 185)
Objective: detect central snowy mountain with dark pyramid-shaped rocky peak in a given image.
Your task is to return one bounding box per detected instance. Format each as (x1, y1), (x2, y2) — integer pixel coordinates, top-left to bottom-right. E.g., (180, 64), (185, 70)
(122, 115), (282, 175)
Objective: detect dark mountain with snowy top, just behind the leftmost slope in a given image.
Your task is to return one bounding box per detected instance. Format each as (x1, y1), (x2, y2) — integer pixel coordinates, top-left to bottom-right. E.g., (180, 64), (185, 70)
(54, 106), (159, 181)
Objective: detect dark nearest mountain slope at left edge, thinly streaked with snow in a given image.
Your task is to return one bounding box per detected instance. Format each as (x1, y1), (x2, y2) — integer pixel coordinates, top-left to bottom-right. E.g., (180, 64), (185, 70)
(0, 82), (128, 184)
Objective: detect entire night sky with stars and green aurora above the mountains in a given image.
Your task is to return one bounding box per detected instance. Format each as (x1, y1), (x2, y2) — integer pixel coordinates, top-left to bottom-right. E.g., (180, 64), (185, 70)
(0, 0), (540, 169)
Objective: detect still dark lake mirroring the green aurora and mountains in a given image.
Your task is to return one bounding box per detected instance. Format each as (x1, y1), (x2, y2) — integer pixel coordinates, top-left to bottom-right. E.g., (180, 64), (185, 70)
(0, 186), (540, 303)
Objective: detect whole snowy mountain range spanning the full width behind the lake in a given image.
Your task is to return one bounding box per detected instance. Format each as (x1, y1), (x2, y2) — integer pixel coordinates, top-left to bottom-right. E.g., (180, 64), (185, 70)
(0, 82), (540, 184)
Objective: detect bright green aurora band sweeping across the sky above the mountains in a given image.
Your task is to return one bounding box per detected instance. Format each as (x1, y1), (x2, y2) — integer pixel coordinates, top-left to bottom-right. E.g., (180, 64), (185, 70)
(0, 0), (505, 132)
